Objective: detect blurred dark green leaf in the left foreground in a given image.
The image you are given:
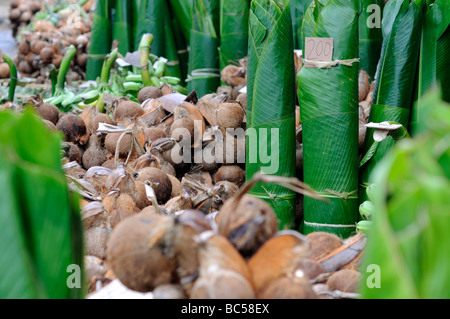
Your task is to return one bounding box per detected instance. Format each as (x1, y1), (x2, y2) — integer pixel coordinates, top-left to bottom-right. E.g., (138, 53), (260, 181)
(0, 109), (85, 299)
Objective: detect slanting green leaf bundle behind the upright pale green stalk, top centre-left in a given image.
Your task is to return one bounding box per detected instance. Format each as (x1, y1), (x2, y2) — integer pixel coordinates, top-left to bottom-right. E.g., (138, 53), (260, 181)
(135, 0), (181, 77)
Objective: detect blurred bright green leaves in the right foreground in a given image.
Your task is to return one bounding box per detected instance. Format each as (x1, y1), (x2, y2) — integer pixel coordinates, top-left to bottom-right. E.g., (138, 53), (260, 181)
(361, 91), (450, 299)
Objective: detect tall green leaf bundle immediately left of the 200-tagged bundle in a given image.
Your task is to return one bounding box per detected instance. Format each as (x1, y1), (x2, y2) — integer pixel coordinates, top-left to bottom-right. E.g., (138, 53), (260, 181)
(246, 0), (295, 229)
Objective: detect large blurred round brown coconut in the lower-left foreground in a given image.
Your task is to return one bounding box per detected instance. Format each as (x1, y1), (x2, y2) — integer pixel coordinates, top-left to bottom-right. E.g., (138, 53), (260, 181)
(107, 214), (177, 292)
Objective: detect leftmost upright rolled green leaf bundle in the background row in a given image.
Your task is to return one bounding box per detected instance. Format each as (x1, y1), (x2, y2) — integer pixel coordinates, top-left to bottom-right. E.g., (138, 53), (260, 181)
(86, 0), (112, 81)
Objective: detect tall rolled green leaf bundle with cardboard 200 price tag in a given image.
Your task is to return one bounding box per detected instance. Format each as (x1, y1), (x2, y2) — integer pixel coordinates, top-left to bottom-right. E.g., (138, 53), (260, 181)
(297, 0), (359, 237)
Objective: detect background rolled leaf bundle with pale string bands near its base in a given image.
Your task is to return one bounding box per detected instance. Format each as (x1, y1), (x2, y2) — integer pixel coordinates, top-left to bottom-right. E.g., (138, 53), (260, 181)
(186, 0), (220, 97)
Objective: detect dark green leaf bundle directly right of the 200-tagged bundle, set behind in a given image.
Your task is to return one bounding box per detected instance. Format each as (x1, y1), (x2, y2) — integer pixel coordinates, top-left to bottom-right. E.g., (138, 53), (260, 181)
(359, 0), (384, 80)
